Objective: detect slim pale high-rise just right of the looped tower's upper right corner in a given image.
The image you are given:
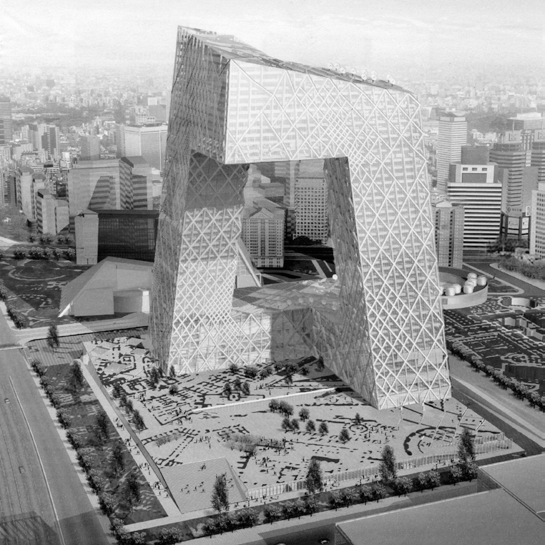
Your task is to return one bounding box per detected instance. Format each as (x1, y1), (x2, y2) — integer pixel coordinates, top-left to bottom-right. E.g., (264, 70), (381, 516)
(437, 113), (467, 193)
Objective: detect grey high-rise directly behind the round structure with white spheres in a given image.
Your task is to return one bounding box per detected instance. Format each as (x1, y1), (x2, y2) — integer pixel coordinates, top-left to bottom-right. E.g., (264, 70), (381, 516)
(432, 198), (464, 268)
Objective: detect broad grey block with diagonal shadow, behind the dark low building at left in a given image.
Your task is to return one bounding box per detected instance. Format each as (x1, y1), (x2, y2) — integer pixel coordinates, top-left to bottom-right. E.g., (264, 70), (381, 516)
(68, 159), (120, 217)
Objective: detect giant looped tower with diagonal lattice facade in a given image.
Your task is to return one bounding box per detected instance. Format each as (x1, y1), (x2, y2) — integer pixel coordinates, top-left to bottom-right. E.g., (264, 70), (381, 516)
(150, 28), (450, 408)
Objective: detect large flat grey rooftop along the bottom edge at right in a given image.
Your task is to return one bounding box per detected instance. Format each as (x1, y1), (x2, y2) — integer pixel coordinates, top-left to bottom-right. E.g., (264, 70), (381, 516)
(337, 488), (545, 545)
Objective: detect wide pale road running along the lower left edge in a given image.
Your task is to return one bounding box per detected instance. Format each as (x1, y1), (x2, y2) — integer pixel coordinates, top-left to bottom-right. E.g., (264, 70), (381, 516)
(0, 310), (109, 545)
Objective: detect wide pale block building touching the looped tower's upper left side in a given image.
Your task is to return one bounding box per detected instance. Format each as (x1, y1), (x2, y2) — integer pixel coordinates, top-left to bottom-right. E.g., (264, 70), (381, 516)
(117, 124), (168, 170)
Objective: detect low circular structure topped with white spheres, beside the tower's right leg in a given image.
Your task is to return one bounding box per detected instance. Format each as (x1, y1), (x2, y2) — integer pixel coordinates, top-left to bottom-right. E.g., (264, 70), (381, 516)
(439, 267), (488, 309)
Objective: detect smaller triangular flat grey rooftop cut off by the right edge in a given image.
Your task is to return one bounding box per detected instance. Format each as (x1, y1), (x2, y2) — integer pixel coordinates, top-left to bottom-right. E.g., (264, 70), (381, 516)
(482, 454), (545, 516)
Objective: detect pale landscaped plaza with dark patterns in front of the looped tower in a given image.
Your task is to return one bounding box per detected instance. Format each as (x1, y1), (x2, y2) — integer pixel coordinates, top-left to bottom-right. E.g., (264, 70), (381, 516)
(83, 337), (520, 512)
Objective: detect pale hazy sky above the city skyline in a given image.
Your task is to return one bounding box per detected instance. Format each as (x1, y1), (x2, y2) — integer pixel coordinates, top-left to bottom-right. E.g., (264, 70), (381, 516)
(0, 0), (545, 76)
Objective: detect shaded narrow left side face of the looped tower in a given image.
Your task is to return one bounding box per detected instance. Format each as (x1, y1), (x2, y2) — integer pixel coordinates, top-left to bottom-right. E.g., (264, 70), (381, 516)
(150, 27), (233, 370)
